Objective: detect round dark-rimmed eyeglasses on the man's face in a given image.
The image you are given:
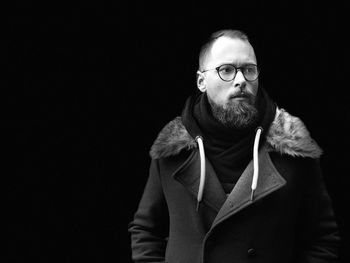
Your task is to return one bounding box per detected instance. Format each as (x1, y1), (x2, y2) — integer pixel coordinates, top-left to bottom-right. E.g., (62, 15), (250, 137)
(202, 64), (259, 81)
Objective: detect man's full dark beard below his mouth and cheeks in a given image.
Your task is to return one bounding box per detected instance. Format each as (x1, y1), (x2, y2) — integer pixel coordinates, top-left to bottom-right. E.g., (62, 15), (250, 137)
(207, 94), (259, 129)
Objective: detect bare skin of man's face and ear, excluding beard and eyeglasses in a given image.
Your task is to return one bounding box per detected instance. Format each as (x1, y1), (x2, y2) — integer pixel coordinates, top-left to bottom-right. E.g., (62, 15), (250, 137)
(197, 37), (258, 108)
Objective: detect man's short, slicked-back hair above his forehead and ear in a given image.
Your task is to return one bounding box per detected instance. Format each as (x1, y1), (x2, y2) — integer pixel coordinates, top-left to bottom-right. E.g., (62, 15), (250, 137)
(199, 29), (249, 71)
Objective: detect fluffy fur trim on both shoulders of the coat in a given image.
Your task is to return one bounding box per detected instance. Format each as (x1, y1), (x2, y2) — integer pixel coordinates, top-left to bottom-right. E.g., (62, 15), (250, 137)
(150, 108), (322, 159)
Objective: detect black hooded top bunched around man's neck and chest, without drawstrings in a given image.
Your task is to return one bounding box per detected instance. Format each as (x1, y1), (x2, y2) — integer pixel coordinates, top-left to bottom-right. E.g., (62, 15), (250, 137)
(182, 87), (276, 192)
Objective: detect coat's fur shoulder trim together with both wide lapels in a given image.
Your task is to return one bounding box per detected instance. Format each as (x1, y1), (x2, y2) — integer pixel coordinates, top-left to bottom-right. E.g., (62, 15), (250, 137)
(150, 108), (322, 228)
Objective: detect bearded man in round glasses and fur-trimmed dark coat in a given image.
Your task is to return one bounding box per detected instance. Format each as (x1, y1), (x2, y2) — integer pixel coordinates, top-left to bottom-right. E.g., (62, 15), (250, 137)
(129, 30), (339, 263)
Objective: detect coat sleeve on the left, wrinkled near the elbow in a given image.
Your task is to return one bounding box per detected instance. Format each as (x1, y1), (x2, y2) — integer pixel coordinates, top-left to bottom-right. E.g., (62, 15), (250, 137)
(128, 160), (169, 262)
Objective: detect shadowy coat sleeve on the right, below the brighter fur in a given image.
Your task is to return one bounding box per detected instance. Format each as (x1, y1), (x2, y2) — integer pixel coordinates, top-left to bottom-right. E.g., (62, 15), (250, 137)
(297, 160), (340, 263)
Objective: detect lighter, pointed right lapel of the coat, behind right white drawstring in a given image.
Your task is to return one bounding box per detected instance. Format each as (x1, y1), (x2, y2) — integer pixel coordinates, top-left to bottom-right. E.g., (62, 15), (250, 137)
(212, 148), (286, 228)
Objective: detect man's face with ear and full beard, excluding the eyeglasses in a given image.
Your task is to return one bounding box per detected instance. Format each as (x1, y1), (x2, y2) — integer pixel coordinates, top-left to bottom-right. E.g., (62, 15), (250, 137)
(197, 37), (259, 128)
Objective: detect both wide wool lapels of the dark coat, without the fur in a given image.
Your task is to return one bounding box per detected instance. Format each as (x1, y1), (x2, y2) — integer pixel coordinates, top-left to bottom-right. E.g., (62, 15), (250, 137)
(173, 148), (286, 225)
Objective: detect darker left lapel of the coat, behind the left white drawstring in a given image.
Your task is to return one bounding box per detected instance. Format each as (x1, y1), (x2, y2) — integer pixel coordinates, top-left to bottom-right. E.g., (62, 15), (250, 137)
(173, 150), (226, 212)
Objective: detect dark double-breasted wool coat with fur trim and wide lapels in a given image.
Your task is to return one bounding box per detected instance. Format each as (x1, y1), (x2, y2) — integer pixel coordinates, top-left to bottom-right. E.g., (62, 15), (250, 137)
(129, 109), (339, 263)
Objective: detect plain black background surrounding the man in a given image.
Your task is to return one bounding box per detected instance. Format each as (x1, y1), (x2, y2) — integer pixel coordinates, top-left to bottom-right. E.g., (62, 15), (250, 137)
(6, 1), (350, 262)
